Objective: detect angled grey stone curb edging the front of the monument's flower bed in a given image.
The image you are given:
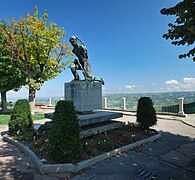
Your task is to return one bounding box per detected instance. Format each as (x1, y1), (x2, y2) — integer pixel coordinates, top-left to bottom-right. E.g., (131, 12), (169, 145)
(3, 132), (162, 173)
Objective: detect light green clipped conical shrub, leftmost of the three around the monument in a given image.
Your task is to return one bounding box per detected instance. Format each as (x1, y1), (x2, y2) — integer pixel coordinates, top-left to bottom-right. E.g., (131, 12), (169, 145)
(8, 99), (33, 134)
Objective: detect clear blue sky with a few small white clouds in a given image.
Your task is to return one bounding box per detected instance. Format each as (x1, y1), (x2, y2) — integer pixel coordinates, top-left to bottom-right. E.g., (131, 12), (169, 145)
(0, 0), (195, 98)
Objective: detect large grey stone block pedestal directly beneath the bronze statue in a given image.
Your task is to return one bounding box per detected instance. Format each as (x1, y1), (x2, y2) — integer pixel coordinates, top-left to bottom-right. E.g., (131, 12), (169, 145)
(64, 81), (102, 113)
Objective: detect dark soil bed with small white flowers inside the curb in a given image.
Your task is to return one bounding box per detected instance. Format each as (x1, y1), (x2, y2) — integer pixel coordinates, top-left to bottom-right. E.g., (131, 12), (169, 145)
(19, 124), (156, 163)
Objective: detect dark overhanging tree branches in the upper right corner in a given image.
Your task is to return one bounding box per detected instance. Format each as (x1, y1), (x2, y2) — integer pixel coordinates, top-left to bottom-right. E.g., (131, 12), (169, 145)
(161, 0), (195, 61)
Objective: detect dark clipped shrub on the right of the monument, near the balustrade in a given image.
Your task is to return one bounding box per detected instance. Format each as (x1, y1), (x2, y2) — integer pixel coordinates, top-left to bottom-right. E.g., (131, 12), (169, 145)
(136, 97), (157, 130)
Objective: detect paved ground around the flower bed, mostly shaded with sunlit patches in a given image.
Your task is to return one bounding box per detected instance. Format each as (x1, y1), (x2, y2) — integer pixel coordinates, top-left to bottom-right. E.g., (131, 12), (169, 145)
(0, 112), (195, 180)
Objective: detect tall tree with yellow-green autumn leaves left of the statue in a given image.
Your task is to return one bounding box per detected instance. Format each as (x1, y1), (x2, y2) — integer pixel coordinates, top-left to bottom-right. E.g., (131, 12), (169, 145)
(2, 7), (71, 108)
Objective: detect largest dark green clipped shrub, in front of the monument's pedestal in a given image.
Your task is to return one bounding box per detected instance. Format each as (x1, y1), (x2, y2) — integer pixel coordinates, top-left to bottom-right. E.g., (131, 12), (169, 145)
(48, 100), (81, 162)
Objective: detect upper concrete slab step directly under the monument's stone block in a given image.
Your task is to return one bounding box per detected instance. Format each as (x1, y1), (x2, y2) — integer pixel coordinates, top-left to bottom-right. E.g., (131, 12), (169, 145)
(44, 111), (123, 126)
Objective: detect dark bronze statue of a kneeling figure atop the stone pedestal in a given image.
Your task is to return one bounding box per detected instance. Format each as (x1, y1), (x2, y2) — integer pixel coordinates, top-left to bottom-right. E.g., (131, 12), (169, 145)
(69, 36), (104, 85)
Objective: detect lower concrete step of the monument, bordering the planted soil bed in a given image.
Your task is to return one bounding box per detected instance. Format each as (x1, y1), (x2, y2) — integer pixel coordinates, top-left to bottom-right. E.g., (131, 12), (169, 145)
(80, 120), (123, 138)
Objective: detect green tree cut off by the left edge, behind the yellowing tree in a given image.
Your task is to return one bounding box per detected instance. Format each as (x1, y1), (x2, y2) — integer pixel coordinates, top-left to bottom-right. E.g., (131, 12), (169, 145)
(0, 29), (23, 112)
